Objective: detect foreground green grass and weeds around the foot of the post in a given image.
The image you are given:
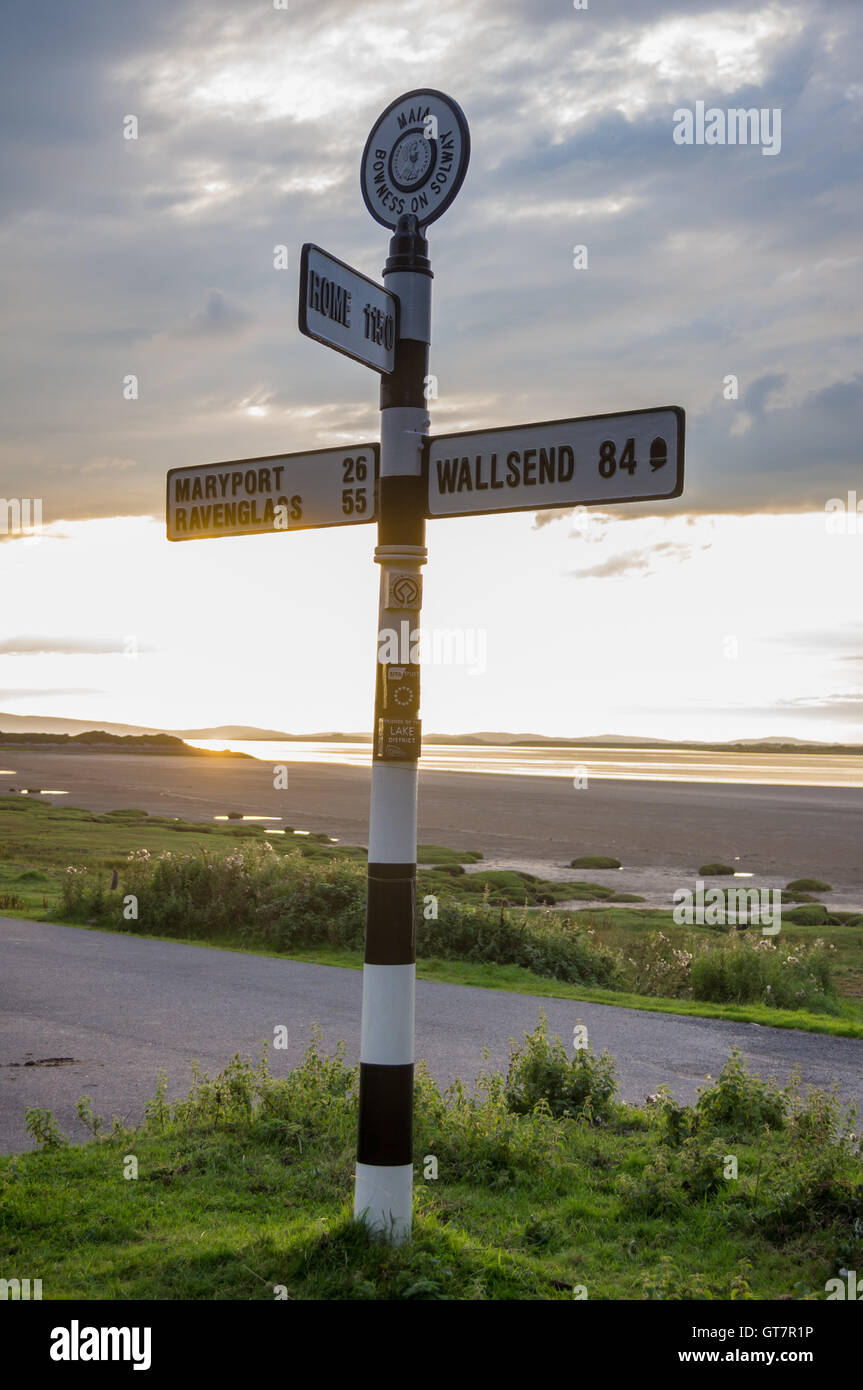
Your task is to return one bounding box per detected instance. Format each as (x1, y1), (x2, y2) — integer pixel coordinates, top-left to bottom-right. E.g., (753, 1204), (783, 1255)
(0, 1024), (863, 1301)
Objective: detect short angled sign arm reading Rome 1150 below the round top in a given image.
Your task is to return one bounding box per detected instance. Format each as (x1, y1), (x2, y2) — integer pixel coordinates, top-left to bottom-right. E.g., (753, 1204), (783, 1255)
(299, 242), (399, 373)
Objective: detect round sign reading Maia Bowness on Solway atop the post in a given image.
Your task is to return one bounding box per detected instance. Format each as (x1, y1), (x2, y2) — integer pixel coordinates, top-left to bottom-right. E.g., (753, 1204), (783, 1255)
(360, 88), (471, 228)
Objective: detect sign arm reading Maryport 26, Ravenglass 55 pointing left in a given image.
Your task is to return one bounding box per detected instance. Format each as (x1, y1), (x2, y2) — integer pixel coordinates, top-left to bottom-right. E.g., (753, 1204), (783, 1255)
(167, 443), (379, 541)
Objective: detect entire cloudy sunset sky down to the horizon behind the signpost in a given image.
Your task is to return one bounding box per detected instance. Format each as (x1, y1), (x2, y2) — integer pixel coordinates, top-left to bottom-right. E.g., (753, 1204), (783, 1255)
(0, 0), (863, 741)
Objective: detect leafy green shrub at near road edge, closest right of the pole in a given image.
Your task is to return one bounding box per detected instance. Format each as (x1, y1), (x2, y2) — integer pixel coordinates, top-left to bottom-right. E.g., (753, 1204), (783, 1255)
(504, 1009), (617, 1123)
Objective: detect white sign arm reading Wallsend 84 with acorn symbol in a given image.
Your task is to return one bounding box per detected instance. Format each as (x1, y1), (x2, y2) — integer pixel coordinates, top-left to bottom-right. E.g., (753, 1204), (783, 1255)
(424, 406), (684, 517)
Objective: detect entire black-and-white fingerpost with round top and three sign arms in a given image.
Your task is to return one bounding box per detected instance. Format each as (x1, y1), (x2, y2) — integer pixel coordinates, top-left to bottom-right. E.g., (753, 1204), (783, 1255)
(167, 89), (684, 1241)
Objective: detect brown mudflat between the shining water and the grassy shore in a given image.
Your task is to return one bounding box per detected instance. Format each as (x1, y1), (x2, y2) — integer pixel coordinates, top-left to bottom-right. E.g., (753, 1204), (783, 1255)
(6, 748), (863, 888)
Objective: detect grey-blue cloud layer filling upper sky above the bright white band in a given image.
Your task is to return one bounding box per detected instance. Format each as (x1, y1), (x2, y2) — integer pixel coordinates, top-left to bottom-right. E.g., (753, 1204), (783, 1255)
(0, 0), (863, 524)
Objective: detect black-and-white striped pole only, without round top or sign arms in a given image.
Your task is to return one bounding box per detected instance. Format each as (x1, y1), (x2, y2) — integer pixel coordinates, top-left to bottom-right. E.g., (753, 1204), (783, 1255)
(354, 215), (431, 1241)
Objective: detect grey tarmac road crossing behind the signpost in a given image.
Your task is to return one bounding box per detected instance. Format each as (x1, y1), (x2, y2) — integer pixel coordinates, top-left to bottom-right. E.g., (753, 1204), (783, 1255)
(0, 917), (863, 1154)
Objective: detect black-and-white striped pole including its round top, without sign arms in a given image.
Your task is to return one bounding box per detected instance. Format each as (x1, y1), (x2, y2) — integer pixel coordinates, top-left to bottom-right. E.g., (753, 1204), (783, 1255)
(354, 92), (470, 1243)
